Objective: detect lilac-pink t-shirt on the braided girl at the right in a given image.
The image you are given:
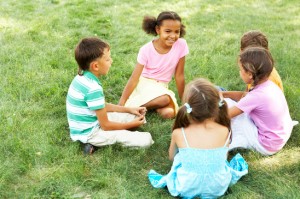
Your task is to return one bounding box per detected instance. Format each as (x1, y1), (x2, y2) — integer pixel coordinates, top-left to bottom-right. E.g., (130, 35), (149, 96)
(236, 80), (293, 152)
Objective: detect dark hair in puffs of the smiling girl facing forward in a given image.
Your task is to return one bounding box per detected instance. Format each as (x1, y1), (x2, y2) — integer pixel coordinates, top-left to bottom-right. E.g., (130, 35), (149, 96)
(142, 11), (185, 37)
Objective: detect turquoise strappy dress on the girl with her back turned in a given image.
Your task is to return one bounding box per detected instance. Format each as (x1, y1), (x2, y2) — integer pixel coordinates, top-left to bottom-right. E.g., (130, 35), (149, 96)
(155, 126), (248, 198)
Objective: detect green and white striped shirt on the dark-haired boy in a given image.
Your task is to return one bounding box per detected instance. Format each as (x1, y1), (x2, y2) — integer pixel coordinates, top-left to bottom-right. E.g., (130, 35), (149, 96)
(66, 71), (105, 143)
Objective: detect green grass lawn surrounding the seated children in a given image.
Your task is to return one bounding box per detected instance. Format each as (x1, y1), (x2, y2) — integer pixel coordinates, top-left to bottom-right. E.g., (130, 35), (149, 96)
(0, 0), (300, 198)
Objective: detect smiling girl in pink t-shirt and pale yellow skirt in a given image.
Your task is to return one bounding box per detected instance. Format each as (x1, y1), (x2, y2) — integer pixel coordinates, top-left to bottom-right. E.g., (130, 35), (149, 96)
(119, 11), (189, 118)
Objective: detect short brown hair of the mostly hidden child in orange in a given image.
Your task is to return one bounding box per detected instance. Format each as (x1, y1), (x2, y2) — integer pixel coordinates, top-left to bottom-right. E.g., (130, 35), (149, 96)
(241, 30), (269, 51)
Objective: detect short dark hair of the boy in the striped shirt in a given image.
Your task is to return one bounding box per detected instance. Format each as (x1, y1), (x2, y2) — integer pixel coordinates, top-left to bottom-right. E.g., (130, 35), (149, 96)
(75, 37), (109, 75)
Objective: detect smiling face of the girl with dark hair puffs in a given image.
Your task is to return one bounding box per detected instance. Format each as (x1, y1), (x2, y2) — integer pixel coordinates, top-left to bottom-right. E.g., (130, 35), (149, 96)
(156, 19), (181, 48)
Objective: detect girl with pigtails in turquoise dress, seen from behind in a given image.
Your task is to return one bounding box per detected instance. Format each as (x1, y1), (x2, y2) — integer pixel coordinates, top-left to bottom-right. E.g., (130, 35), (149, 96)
(148, 79), (248, 198)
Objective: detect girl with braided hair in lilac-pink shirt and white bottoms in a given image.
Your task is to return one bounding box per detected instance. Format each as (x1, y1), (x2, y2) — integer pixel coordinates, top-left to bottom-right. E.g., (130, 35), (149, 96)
(223, 47), (293, 155)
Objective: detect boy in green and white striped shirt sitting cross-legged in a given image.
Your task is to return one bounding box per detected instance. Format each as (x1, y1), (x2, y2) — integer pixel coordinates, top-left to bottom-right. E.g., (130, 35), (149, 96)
(66, 38), (153, 154)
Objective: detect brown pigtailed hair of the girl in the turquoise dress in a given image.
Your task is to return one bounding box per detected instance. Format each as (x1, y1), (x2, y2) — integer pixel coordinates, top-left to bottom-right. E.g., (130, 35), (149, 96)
(173, 78), (231, 130)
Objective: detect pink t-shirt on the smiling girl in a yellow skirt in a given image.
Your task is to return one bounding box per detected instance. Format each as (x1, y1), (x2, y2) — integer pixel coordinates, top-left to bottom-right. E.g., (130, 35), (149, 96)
(137, 38), (189, 83)
